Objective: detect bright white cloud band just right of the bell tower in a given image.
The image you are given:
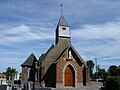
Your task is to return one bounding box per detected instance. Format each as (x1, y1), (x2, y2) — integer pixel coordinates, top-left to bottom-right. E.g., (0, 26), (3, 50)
(72, 21), (120, 40)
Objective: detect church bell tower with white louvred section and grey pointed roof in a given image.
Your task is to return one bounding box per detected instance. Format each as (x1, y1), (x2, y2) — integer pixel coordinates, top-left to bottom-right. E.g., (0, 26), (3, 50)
(56, 15), (70, 45)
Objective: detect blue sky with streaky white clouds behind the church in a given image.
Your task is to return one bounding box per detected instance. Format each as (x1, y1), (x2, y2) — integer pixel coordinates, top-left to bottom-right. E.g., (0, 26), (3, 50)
(0, 0), (120, 72)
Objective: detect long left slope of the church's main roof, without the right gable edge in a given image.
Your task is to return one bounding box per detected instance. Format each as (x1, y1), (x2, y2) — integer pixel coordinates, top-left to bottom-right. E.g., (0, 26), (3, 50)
(39, 40), (68, 72)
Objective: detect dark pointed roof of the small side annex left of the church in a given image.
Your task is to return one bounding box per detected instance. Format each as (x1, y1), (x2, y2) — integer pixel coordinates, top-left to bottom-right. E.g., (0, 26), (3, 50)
(21, 53), (37, 67)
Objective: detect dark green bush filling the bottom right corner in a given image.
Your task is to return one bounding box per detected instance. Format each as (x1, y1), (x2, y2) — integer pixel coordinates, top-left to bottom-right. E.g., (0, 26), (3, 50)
(105, 76), (120, 90)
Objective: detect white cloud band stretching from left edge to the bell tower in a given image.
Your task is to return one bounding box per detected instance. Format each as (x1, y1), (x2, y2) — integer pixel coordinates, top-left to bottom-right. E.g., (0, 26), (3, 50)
(0, 25), (53, 45)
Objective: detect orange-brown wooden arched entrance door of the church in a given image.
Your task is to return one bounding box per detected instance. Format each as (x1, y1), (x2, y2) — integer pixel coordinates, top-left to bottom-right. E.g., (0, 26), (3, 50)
(64, 65), (75, 87)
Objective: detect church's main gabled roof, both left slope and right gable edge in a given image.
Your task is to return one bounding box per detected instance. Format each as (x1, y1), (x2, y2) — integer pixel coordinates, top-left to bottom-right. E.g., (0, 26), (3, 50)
(39, 44), (85, 72)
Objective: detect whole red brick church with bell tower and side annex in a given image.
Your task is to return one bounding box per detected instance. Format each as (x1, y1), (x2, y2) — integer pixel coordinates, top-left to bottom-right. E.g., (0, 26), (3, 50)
(21, 15), (90, 87)
